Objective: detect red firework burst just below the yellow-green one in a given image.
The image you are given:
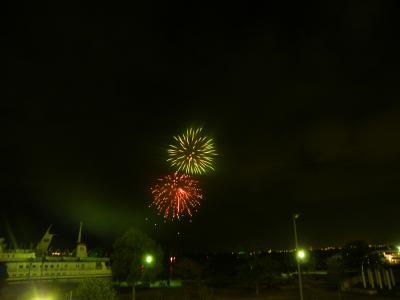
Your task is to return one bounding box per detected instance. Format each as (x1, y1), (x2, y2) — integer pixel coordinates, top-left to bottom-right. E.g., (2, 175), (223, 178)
(150, 173), (203, 220)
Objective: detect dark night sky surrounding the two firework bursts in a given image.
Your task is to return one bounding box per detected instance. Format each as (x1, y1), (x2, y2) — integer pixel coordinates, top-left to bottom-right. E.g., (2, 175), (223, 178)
(0, 0), (400, 251)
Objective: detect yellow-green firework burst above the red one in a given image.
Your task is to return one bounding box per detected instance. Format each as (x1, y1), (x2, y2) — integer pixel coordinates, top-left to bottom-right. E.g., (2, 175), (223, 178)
(167, 128), (217, 174)
